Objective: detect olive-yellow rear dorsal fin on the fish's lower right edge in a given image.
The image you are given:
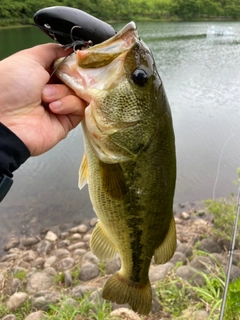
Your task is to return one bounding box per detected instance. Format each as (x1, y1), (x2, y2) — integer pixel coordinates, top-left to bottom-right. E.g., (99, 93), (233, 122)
(154, 216), (177, 264)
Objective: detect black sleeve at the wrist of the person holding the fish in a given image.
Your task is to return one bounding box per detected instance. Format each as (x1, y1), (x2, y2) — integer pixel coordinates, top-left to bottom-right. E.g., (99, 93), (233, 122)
(0, 122), (30, 202)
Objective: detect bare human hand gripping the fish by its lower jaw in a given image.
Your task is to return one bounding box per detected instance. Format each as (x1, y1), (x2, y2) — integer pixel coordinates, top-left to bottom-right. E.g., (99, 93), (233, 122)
(0, 43), (86, 156)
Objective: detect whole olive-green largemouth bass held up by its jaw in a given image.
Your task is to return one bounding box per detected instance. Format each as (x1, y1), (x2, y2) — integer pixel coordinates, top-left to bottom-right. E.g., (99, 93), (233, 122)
(57, 22), (176, 314)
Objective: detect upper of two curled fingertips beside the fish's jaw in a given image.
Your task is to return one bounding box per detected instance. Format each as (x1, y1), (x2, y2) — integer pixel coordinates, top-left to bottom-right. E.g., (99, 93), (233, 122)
(42, 84), (74, 103)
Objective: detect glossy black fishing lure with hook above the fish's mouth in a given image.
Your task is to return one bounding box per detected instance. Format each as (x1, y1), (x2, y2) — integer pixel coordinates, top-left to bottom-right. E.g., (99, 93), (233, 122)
(33, 6), (116, 49)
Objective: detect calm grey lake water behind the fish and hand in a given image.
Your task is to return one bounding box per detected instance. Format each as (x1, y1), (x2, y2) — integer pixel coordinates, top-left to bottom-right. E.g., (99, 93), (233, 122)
(0, 22), (240, 249)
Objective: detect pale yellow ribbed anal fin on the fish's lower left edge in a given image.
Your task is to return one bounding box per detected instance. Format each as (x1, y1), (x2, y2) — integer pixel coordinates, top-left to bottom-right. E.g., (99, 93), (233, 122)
(90, 221), (117, 260)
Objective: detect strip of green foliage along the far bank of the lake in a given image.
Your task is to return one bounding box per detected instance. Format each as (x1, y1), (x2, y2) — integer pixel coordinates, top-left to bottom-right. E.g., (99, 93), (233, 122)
(0, 0), (240, 26)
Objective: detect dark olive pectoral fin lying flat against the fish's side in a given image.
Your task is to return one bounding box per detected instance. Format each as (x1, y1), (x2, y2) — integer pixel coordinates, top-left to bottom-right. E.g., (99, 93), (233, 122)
(100, 161), (127, 200)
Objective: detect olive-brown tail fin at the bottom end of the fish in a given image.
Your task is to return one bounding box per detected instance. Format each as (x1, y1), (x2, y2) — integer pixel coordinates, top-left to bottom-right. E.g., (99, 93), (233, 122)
(102, 272), (152, 315)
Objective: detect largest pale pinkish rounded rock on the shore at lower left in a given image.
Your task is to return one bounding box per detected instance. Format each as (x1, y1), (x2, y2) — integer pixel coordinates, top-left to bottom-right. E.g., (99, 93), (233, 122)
(26, 272), (54, 293)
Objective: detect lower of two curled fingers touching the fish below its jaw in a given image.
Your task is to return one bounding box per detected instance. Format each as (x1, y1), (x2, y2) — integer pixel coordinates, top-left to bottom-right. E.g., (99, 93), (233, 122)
(49, 95), (86, 118)
